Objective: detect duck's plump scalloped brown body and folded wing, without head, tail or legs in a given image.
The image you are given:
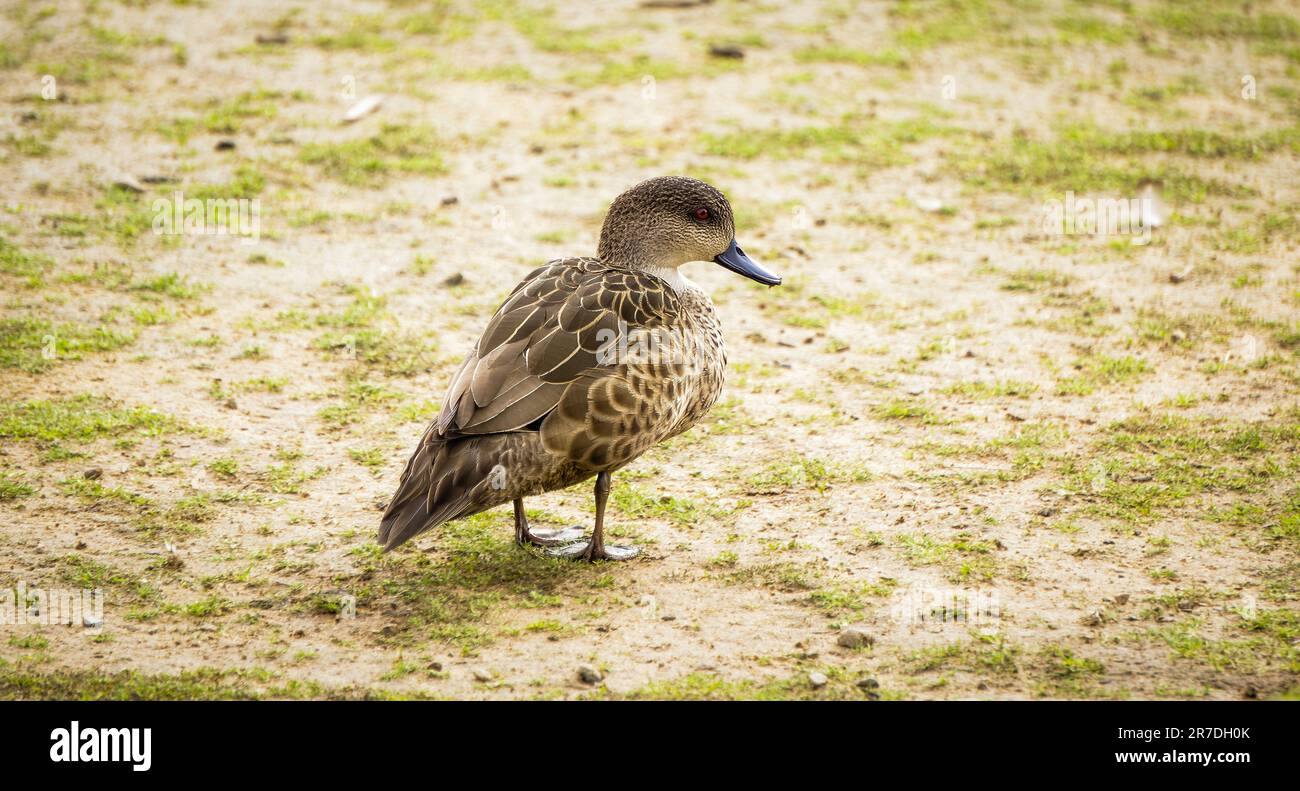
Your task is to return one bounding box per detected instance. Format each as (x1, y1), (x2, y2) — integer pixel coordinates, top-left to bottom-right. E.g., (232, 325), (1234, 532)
(437, 258), (725, 471)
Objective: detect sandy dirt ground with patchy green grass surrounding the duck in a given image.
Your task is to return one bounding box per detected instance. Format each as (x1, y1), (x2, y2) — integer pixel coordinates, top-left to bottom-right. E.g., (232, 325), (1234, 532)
(0, 0), (1300, 700)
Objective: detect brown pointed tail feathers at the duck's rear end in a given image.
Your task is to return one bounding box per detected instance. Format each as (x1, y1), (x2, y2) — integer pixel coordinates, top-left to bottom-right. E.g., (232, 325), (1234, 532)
(378, 432), (495, 552)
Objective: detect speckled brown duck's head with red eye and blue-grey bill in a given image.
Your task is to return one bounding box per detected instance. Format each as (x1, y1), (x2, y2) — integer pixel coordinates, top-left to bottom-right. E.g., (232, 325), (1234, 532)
(599, 176), (781, 286)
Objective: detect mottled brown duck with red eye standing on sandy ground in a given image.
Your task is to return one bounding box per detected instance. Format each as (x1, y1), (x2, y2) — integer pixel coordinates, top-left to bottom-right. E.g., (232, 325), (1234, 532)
(378, 176), (781, 561)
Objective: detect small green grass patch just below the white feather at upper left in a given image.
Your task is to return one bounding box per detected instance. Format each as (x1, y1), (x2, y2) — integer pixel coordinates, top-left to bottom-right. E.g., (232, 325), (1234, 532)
(299, 124), (447, 186)
